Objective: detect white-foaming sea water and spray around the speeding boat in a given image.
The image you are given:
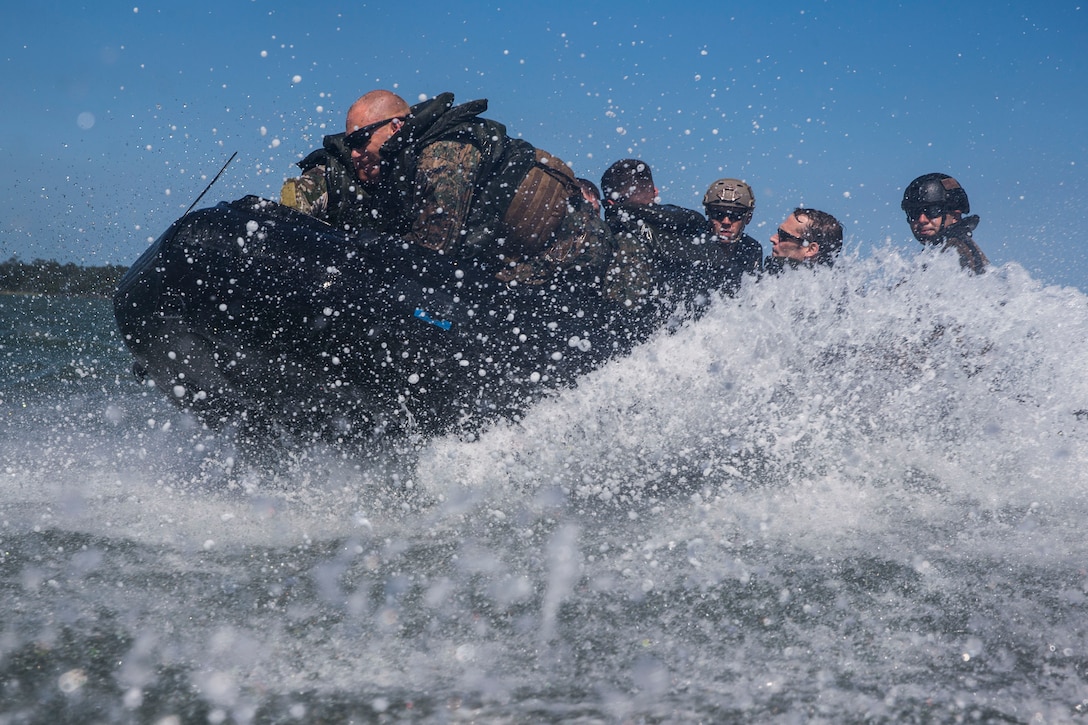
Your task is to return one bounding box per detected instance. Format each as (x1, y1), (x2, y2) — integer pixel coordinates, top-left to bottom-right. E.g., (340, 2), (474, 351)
(0, 249), (1088, 723)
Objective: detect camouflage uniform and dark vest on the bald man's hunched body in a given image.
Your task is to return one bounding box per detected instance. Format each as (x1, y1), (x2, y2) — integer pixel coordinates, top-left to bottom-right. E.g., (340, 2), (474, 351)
(367, 94), (631, 288)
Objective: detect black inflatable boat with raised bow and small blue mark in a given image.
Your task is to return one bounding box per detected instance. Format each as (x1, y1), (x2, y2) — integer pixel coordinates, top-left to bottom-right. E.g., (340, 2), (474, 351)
(114, 196), (645, 438)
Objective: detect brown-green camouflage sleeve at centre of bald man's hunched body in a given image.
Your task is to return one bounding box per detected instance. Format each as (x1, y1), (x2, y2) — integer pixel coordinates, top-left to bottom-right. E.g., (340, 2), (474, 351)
(406, 142), (480, 256)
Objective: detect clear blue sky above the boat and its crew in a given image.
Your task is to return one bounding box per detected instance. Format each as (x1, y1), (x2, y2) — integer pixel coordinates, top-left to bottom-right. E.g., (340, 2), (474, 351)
(0, 0), (1088, 291)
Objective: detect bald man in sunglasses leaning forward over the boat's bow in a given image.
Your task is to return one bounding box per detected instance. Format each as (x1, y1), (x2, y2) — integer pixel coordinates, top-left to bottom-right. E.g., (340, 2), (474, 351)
(281, 90), (616, 284)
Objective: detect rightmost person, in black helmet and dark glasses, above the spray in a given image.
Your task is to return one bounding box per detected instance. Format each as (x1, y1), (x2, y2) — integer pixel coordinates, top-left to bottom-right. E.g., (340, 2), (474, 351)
(901, 173), (990, 274)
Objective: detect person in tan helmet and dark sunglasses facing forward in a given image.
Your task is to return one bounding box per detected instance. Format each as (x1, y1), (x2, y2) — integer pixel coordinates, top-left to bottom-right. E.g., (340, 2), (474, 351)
(703, 179), (763, 294)
